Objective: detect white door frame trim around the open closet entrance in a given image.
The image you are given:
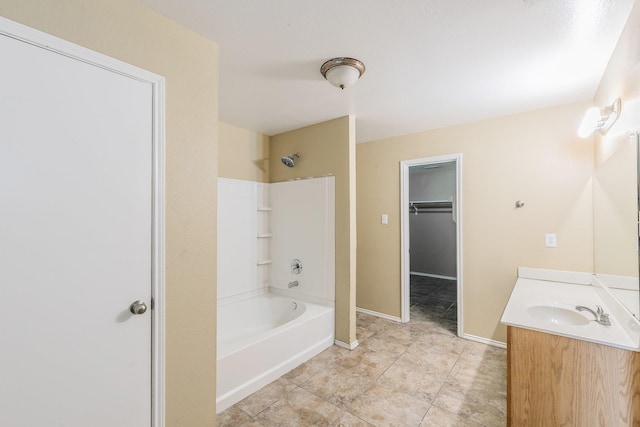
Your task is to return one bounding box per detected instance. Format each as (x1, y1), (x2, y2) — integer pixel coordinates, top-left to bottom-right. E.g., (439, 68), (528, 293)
(400, 153), (464, 336)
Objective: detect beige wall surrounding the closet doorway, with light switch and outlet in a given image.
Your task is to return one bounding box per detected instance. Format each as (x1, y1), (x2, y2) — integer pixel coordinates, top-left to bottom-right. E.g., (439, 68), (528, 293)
(356, 103), (593, 342)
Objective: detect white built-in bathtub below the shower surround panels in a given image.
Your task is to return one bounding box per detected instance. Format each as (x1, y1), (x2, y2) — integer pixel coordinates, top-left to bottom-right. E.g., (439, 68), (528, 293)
(216, 293), (334, 412)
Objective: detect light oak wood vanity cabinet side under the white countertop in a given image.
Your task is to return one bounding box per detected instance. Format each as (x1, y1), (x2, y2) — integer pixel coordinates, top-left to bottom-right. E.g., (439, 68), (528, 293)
(507, 326), (640, 427)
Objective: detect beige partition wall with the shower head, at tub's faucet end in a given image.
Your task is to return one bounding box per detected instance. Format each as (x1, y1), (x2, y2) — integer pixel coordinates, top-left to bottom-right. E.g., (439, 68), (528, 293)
(269, 116), (356, 344)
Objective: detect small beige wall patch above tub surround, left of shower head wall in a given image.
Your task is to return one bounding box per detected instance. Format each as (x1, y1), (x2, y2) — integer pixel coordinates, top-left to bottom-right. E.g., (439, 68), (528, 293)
(218, 122), (269, 182)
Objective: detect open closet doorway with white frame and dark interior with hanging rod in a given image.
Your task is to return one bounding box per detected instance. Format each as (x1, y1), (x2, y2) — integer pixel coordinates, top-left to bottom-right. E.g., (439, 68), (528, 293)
(401, 154), (463, 336)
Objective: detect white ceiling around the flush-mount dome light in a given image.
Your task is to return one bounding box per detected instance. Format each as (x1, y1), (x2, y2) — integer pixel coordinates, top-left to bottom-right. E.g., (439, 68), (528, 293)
(142, 0), (634, 142)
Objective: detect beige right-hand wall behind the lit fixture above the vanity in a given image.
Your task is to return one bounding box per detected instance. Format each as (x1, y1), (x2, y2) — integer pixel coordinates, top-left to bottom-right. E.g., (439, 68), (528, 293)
(593, 1), (640, 276)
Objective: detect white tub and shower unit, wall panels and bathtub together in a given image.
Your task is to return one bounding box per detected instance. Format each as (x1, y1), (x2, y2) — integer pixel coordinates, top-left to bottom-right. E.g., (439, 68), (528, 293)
(216, 177), (335, 412)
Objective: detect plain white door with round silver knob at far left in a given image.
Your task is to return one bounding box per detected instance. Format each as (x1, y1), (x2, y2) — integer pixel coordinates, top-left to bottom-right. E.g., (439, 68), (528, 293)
(0, 22), (158, 427)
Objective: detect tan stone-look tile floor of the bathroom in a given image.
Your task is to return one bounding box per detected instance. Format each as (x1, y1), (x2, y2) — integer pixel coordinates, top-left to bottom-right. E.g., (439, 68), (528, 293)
(217, 283), (506, 427)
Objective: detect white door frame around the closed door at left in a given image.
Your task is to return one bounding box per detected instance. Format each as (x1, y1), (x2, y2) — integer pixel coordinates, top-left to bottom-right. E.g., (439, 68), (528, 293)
(0, 17), (165, 427)
